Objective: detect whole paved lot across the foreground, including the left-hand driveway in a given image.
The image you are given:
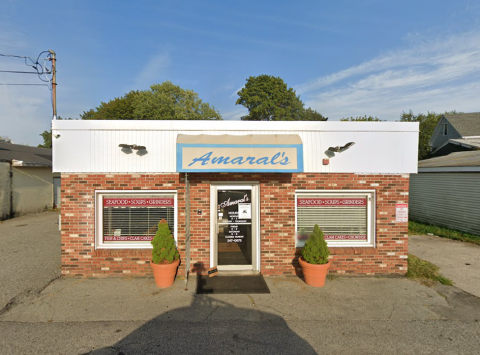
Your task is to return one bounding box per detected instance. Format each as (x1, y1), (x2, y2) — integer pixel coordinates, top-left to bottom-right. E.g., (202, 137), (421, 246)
(0, 212), (480, 354)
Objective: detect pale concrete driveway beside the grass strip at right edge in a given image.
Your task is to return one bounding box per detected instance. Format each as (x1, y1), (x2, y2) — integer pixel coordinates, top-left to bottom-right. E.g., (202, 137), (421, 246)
(408, 235), (480, 297)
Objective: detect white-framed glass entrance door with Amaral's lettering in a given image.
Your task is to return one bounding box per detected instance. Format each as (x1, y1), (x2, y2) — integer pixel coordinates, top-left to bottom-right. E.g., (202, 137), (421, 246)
(212, 186), (257, 270)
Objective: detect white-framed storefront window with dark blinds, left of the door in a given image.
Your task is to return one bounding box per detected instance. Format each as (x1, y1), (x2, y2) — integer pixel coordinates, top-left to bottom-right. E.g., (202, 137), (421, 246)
(96, 191), (177, 248)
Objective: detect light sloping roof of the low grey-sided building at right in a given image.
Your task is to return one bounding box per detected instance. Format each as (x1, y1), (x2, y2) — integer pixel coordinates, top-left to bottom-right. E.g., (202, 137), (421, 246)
(418, 150), (480, 172)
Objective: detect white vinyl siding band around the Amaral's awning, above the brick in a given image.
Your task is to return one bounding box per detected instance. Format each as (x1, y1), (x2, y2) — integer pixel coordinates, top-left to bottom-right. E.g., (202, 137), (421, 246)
(52, 120), (418, 174)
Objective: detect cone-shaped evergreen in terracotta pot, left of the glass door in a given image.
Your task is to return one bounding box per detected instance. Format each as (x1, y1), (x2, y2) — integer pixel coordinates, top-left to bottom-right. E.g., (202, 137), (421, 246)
(150, 219), (180, 288)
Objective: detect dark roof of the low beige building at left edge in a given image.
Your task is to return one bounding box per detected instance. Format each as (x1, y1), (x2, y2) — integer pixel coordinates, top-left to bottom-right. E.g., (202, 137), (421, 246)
(0, 143), (52, 167)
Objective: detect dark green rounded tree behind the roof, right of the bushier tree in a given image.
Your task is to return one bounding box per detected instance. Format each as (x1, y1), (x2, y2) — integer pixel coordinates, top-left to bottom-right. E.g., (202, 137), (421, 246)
(236, 75), (327, 121)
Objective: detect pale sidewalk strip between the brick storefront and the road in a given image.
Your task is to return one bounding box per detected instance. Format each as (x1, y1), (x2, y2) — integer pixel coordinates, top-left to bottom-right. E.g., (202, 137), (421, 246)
(2, 277), (468, 322)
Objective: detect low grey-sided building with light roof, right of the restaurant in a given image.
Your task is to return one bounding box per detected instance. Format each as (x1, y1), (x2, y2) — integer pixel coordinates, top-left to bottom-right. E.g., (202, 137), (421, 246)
(410, 151), (480, 235)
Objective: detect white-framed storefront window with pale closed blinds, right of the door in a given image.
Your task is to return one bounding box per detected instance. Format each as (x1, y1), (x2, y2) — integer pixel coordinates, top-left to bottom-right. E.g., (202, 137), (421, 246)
(296, 191), (375, 247)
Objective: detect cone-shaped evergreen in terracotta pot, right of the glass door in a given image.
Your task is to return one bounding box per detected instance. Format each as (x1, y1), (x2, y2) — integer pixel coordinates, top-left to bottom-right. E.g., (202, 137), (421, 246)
(298, 224), (331, 287)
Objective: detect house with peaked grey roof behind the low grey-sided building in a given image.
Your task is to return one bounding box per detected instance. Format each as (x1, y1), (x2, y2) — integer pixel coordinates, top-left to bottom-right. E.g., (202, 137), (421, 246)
(429, 112), (480, 157)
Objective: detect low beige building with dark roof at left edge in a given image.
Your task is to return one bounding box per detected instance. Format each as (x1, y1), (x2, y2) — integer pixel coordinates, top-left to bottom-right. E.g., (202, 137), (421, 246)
(0, 143), (60, 220)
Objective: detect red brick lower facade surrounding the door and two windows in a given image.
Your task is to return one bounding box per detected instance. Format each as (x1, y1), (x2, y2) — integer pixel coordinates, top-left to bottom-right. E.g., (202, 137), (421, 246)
(62, 173), (409, 277)
